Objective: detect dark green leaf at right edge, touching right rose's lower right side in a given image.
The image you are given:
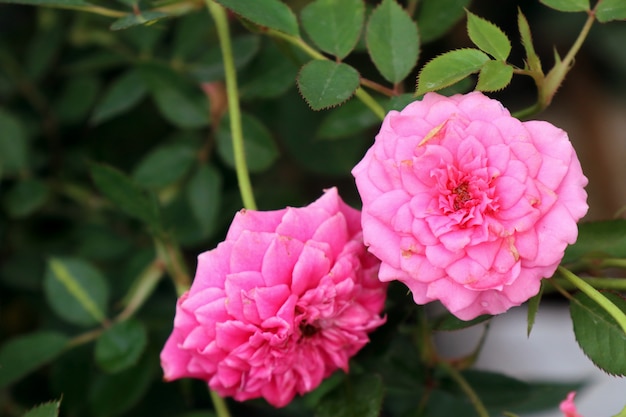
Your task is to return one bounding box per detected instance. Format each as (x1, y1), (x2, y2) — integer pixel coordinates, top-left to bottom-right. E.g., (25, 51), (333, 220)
(563, 219), (626, 263)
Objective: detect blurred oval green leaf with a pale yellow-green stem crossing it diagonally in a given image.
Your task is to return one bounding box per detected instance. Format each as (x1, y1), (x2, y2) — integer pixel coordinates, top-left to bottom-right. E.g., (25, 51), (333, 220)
(44, 258), (109, 326)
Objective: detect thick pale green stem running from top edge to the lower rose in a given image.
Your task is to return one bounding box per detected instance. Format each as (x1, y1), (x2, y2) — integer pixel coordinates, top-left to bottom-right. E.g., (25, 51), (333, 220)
(206, 0), (257, 210)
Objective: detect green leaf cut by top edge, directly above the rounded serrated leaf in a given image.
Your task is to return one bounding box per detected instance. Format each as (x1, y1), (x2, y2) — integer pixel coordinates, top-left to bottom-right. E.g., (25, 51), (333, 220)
(300, 0), (365, 59)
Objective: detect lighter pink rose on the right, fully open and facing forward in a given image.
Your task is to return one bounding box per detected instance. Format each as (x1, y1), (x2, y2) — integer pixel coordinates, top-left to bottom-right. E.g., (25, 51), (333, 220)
(352, 92), (588, 320)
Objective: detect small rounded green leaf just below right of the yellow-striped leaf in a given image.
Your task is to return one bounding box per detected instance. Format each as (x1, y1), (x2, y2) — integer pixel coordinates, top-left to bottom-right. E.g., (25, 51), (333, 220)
(95, 319), (148, 373)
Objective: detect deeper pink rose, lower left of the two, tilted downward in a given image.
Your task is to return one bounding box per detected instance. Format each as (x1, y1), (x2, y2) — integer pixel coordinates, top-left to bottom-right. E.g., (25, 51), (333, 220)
(161, 188), (386, 407)
